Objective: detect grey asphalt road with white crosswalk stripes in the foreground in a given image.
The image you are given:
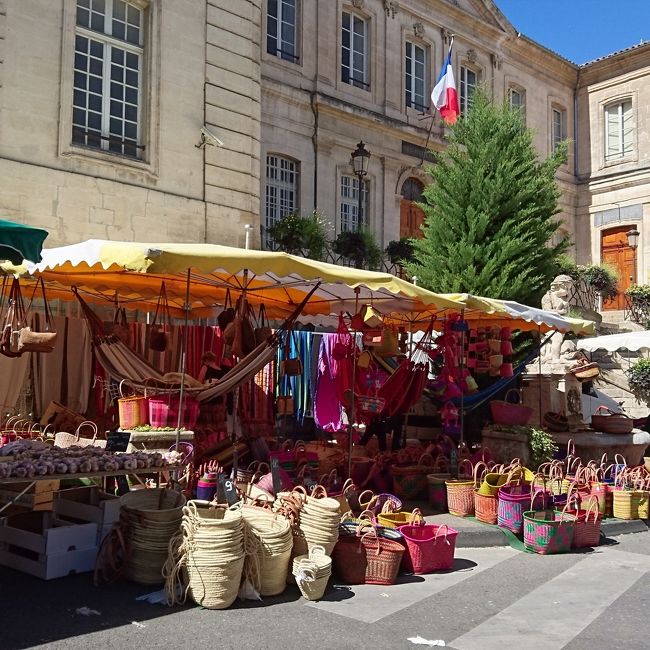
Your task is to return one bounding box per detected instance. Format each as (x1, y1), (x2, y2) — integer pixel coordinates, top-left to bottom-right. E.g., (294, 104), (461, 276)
(0, 532), (650, 650)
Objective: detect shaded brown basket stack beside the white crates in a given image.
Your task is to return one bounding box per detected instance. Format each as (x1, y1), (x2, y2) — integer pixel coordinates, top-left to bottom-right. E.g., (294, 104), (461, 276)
(120, 488), (185, 585)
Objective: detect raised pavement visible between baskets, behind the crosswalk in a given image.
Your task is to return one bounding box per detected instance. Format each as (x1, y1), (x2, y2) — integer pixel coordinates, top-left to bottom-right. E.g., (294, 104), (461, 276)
(405, 502), (650, 548)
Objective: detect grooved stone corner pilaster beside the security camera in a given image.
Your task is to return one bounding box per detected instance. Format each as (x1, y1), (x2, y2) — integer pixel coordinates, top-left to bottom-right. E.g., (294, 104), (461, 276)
(205, 0), (263, 248)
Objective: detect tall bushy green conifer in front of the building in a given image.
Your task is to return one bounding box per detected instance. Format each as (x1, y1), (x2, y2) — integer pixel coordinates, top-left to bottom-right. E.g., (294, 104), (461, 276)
(406, 91), (569, 305)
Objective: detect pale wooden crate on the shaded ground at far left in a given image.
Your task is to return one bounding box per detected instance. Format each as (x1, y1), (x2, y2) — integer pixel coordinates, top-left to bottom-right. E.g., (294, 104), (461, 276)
(0, 512), (97, 580)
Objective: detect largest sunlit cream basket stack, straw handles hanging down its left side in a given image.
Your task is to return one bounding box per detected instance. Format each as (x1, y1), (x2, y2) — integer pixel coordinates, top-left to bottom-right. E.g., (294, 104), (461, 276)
(165, 501), (244, 609)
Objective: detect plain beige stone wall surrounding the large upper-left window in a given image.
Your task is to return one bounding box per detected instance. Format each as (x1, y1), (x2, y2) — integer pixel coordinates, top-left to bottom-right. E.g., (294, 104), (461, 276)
(0, 0), (261, 246)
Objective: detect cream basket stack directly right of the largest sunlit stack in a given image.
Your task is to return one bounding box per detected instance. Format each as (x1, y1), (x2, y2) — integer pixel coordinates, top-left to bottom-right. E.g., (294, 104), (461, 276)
(242, 506), (293, 596)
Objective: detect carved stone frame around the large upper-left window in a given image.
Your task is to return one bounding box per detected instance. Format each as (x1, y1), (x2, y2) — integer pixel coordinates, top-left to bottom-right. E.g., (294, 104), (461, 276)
(58, 0), (161, 180)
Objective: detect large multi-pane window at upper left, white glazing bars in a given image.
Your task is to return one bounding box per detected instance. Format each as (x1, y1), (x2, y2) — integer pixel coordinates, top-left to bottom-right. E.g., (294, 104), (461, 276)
(72, 0), (144, 158)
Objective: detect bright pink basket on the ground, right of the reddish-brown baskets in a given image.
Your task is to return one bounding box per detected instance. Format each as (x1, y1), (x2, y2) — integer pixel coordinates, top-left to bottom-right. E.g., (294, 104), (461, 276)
(398, 524), (458, 573)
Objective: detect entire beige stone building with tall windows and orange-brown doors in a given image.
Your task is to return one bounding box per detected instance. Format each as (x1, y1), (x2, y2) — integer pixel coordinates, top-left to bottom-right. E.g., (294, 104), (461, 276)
(0, 0), (650, 316)
